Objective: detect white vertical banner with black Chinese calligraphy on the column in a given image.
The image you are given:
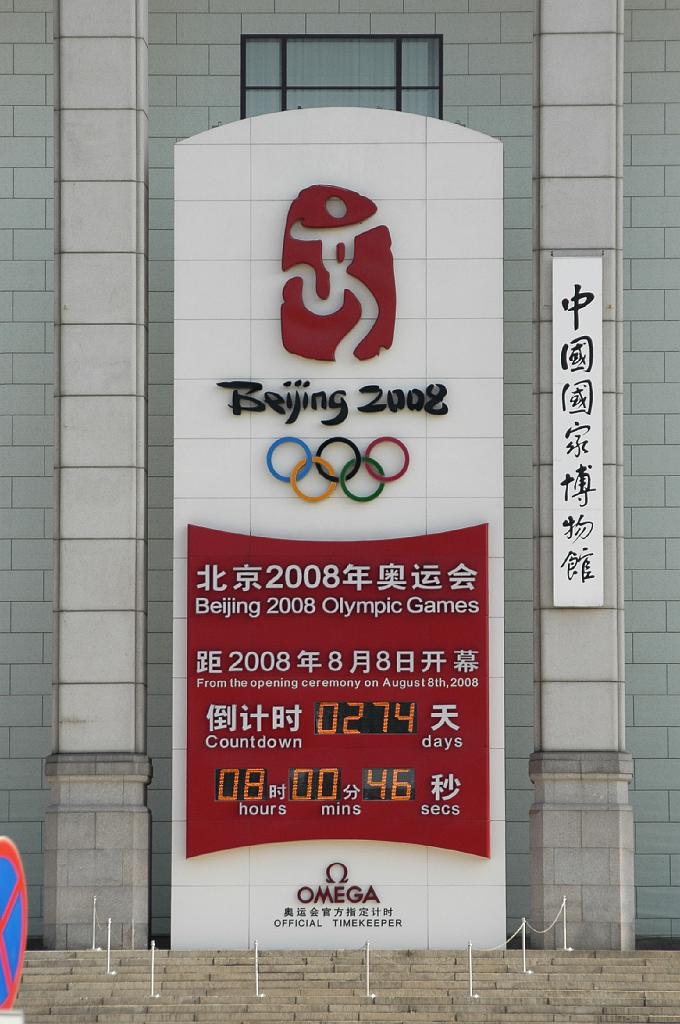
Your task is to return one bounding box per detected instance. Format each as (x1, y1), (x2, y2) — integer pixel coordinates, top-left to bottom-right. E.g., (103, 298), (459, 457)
(552, 256), (604, 608)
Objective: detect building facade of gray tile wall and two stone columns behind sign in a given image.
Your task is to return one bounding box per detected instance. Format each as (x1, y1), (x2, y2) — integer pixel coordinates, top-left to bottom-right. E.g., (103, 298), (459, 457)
(0, 0), (680, 947)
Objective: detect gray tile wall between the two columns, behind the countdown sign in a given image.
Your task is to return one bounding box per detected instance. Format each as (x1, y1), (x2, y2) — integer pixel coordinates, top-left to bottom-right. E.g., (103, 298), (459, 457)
(148, 0), (534, 934)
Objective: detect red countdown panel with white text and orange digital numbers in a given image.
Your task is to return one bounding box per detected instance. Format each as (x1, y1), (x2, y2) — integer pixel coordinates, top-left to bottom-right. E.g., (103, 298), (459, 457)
(186, 525), (488, 857)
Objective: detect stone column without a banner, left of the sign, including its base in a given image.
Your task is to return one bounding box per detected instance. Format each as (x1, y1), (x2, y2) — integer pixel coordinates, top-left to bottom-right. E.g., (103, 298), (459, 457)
(44, 0), (150, 948)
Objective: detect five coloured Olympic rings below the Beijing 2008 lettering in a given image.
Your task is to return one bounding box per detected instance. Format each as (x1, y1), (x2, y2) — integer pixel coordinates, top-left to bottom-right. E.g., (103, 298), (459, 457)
(266, 436), (411, 504)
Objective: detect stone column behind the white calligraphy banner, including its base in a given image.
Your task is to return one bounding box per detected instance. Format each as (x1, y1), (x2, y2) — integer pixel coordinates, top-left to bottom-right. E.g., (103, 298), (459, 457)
(529, 0), (635, 949)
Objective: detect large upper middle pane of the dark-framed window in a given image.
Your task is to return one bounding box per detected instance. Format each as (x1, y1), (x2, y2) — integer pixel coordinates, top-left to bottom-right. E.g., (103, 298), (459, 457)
(287, 38), (393, 86)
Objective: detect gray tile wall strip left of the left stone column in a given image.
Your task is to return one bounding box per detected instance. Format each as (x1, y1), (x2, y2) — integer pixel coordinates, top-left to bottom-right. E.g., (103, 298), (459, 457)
(0, 0), (54, 935)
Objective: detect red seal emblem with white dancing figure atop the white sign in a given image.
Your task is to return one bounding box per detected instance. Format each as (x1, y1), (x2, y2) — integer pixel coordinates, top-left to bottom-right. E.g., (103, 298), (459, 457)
(281, 185), (396, 362)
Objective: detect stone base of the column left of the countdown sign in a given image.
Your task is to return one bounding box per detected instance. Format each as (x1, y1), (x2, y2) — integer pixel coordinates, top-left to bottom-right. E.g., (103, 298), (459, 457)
(44, 754), (152, 949)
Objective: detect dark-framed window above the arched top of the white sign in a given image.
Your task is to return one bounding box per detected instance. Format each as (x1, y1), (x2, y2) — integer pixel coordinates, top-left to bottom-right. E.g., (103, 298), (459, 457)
(241, 36), (441, 118)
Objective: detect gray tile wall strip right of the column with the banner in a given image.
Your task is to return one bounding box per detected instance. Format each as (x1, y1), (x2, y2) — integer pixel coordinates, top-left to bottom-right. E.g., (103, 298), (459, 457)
(624, 0), (680, 939)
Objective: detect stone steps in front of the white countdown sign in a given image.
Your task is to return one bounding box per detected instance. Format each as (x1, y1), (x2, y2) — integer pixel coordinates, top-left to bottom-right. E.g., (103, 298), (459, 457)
(17, 950), (680, 1024)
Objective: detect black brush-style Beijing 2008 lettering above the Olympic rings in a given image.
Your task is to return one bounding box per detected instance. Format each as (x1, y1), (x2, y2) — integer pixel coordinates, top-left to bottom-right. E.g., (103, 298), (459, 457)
(217, 380), (449, 427)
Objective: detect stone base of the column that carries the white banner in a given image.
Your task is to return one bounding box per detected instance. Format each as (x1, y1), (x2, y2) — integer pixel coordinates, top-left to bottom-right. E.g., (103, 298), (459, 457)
(529, 751), (635, 949)
